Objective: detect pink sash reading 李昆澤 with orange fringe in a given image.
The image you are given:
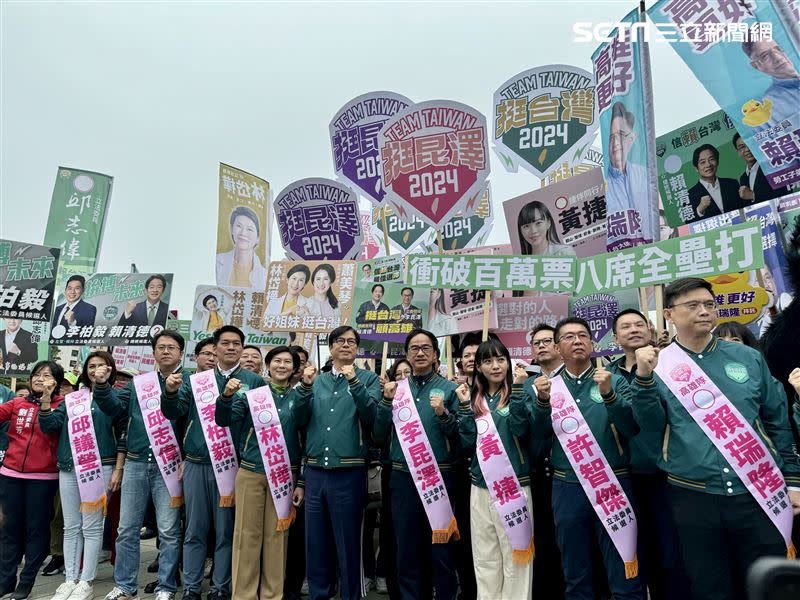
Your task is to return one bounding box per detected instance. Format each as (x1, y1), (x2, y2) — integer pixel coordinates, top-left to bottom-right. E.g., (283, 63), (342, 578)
(392, 379), (461, 544)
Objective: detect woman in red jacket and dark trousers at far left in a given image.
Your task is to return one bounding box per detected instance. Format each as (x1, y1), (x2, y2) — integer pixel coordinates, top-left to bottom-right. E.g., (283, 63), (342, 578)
(0, 360), (64, 600)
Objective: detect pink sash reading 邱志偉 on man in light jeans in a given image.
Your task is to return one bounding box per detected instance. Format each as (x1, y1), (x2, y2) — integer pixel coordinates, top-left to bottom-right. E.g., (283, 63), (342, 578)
(133, 371), (183, 507)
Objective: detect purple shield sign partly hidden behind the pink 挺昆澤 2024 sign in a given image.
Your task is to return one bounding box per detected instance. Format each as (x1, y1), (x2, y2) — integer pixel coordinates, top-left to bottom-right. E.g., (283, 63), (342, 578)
(328, 92), (412, 205)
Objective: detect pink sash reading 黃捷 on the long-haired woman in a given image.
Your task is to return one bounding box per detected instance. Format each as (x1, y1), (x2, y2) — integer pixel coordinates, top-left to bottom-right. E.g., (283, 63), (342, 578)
(475, 412), (534, 565)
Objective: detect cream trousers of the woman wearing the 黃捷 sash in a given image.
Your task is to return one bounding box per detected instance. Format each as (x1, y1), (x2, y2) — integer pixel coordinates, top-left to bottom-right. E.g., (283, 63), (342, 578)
(469, 485), (533, 600)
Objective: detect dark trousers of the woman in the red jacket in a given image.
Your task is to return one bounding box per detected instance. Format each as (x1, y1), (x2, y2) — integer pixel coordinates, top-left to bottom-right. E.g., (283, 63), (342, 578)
(0, 475), (58, 588)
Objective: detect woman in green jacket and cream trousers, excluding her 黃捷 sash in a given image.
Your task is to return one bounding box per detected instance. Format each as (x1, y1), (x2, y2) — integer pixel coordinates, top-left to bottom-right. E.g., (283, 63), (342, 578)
(456, 340), (533, 600)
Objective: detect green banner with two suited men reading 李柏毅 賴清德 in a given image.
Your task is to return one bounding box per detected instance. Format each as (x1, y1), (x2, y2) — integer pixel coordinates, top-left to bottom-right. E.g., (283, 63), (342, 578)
(50, 273), (172, 346)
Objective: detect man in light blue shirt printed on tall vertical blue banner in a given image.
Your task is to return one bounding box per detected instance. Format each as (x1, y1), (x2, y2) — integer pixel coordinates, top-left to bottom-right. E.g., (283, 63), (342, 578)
(606, 101), (658, 244)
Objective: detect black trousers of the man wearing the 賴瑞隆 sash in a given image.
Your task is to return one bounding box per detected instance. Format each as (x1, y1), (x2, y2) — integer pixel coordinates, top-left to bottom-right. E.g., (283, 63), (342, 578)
(670, 486), (786, 600)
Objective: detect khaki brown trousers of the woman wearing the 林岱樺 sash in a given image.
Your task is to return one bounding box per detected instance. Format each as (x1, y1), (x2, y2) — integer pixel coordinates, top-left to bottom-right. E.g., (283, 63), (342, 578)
(231, 469), (289, 600)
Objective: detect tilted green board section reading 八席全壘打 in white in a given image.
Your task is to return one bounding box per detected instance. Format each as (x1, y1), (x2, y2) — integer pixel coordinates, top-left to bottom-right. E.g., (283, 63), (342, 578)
(573, 223), (764, 296)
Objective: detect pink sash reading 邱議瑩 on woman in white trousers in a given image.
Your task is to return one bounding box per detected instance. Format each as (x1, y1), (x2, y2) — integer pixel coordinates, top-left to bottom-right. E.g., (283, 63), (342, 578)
(64, 388), (106, 513)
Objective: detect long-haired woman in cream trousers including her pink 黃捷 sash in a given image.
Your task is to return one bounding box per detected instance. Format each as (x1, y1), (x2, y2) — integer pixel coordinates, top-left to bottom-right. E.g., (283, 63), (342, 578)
(456, 339), (533, 600)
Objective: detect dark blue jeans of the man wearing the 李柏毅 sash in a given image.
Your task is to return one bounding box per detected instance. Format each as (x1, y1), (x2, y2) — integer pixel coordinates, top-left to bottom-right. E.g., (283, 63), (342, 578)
(181, 461), (234, 596)
